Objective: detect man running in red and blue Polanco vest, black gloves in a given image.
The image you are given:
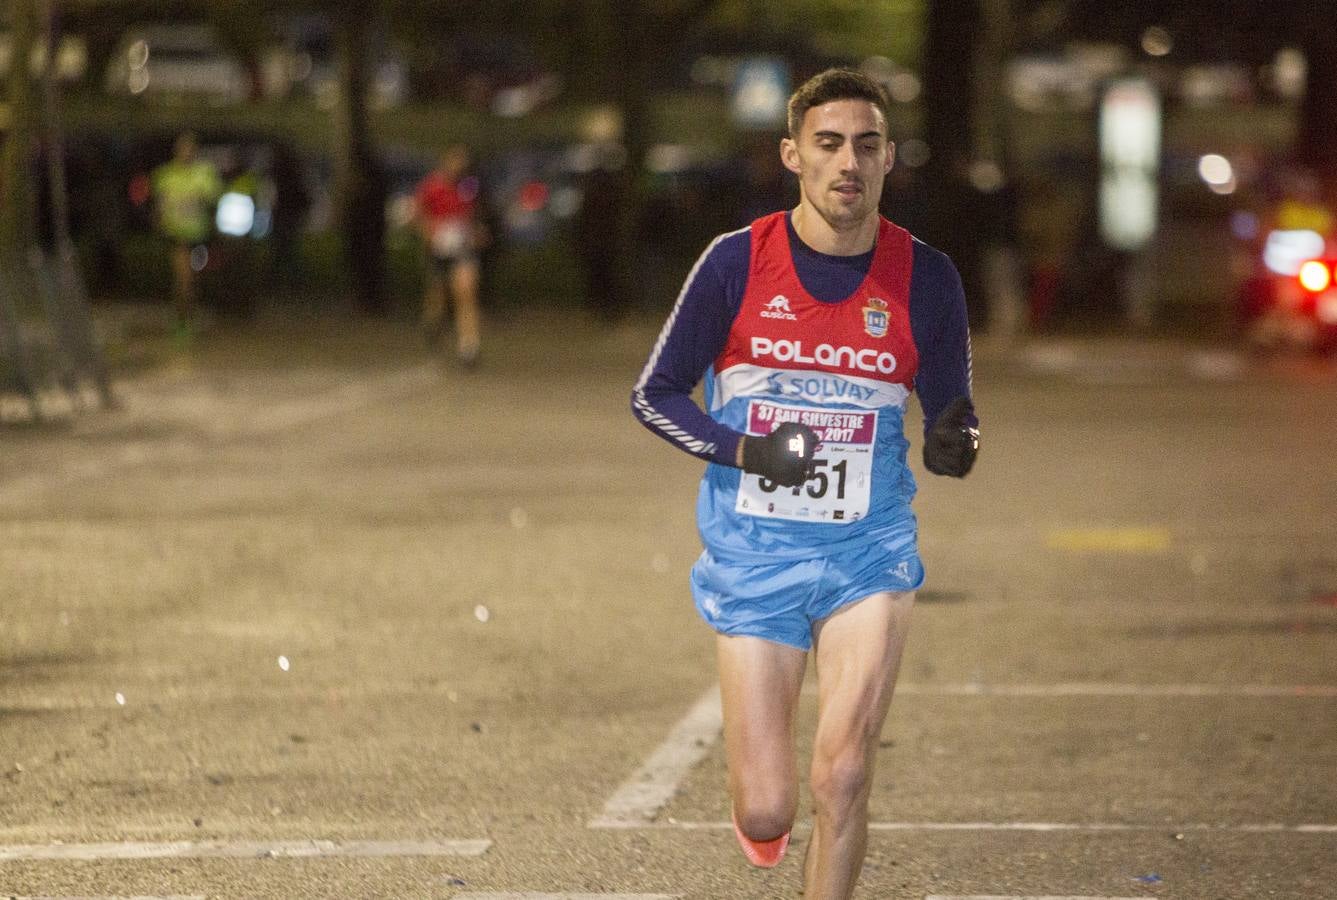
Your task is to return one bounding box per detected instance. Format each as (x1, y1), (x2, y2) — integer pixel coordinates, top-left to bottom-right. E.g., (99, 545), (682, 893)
(631, 70), (979, 900)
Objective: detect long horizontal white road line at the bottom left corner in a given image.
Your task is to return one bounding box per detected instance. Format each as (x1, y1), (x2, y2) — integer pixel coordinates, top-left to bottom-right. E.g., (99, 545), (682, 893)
(0, 840), (492, 861)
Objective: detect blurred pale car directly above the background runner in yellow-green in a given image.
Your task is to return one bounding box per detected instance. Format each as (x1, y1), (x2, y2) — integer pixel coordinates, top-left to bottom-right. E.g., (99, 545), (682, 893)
(106, 25), (253, 104)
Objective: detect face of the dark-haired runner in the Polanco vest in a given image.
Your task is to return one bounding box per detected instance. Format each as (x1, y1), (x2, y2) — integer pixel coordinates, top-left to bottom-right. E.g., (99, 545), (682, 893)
(781, 99), (896, 231)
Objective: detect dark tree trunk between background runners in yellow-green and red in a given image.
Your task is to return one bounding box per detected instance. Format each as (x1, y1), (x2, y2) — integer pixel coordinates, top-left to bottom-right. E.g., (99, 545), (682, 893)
(334, 3), (389, 316)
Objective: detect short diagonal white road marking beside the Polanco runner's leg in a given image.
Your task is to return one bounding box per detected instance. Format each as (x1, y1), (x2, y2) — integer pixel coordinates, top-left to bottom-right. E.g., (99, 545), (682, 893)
(590, 685), (723, 828)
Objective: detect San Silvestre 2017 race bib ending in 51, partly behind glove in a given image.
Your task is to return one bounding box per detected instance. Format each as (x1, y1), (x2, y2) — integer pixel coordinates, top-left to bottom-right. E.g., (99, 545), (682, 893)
(734, 400), (877, 526)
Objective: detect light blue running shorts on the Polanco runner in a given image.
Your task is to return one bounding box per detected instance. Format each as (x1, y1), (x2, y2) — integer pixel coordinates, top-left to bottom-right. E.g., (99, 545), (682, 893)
(691, 531), (924, 651)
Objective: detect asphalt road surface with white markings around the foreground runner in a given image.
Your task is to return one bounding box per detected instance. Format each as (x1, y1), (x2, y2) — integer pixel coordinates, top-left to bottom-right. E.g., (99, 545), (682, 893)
(0, 307), (1337, 900)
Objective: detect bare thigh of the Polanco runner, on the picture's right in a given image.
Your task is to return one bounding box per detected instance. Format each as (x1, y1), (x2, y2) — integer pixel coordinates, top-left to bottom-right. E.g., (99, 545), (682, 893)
(813, 591), (915, 756)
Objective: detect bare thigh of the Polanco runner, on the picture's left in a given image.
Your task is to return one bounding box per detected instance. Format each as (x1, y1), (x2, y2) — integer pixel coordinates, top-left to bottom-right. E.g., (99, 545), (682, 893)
(715, 634), (808, 784)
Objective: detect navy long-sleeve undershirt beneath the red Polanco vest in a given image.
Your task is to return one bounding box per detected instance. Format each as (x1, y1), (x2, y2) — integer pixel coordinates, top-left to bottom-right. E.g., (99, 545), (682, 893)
(631, 217), (971, 465)
